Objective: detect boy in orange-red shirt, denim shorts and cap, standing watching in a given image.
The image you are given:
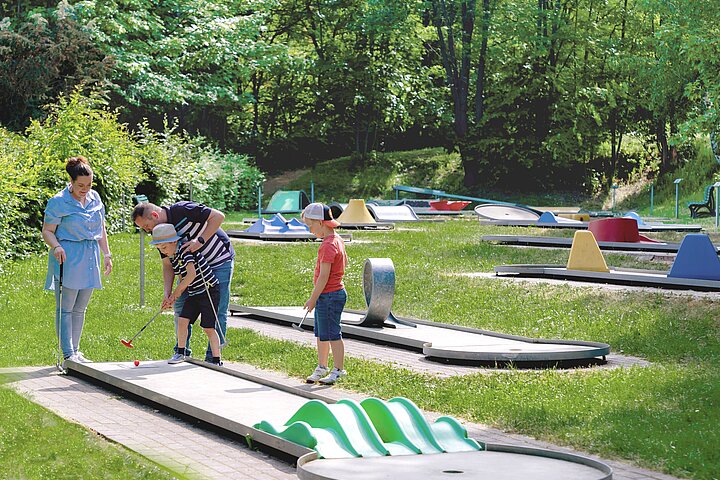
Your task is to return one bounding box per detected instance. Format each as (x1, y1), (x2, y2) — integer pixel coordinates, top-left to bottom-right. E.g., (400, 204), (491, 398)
(302, 203), (347, 385)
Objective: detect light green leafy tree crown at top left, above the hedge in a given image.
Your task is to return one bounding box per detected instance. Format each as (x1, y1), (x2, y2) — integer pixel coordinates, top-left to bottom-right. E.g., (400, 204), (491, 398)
(73, 0), (273, 111)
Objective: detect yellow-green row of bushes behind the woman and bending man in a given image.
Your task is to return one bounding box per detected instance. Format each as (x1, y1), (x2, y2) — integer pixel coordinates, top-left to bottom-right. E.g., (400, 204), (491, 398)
(0, 90), (262, 264)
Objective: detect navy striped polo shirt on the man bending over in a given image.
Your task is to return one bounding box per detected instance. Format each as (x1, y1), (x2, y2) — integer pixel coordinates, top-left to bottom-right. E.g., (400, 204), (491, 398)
(162, 201), (235, 267)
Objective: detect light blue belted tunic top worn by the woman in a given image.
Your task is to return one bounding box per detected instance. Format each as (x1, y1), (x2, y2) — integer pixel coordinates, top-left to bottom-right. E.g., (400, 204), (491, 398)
(45, 187), (105, 290)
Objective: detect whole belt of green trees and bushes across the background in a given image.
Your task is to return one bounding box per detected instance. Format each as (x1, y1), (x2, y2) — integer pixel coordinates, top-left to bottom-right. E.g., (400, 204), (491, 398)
(0, 0), (720, 264)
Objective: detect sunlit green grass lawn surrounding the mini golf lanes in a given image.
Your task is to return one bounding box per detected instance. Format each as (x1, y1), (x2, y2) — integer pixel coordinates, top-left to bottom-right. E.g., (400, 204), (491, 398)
(0, 218), (720, 479)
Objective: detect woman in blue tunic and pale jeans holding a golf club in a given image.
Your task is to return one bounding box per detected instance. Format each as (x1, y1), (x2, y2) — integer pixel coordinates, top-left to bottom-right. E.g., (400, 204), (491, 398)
(42, 156), (112, 364)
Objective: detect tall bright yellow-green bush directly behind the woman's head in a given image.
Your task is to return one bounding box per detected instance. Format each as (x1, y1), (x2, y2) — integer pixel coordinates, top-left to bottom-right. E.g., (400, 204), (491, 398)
(0, 91), (140, 266)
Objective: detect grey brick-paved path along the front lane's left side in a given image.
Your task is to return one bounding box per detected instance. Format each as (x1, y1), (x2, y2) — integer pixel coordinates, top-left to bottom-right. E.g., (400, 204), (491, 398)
(0, 367), (297, 480)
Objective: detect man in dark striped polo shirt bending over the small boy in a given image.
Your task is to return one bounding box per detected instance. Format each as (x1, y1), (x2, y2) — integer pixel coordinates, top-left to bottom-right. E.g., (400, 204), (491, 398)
(132, 201), (235, 361)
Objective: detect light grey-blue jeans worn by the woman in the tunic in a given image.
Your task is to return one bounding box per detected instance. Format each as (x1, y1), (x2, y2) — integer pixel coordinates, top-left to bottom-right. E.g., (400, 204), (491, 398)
(55, 288), (93, 358)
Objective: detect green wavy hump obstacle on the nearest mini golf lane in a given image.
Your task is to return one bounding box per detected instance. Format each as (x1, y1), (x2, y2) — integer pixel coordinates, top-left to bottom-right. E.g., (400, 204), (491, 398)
(255, 397), (484, 458)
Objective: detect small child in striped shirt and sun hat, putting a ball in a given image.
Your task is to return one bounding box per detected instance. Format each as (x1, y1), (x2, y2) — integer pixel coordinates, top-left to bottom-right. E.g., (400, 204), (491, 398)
(150, 223), (222, 365)
